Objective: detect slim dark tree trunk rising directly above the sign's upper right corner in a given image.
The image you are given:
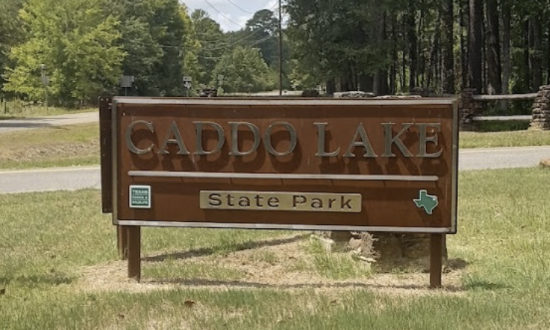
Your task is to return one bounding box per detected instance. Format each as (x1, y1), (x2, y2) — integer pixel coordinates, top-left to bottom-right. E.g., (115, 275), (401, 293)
(441, 0), (455, 94)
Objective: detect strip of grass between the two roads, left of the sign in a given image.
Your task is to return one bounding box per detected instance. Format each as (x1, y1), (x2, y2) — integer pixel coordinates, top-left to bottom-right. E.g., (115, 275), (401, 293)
(0, 123), (99, 169)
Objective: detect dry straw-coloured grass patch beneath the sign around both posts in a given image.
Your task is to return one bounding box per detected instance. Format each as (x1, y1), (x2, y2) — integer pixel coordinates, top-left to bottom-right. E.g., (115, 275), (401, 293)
(77, 235), (464, 299)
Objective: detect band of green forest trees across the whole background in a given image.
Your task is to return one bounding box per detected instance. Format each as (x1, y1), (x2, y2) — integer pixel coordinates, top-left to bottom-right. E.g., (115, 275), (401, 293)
(0, 0), (550, 107)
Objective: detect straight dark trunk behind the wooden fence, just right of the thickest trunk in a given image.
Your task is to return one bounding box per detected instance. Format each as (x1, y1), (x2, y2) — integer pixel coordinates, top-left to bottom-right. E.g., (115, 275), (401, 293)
(486, 0), (502, 94)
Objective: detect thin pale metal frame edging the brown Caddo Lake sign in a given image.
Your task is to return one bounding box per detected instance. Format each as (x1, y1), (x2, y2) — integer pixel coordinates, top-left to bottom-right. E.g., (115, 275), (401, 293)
(110, 97), (458, 234)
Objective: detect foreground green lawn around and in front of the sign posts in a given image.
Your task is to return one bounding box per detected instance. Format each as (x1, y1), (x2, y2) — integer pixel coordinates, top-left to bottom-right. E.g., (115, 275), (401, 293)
(0, 168), (550, 329)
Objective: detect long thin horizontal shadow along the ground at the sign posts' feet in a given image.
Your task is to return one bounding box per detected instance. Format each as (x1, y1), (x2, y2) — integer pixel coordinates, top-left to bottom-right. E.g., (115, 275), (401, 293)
(142, 278), (465, 292)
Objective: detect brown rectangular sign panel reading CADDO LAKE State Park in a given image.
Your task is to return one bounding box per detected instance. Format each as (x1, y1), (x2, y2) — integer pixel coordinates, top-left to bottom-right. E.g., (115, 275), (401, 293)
(111, 97), (458, 233)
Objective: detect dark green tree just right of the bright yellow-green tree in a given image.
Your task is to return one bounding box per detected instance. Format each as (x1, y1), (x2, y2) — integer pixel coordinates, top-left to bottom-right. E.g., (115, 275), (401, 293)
(110, 0), (189, 96)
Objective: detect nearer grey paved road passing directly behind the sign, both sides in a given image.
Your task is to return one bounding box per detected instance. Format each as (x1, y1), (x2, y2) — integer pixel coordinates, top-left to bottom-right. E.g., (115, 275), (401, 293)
(0, 146), (550, 193)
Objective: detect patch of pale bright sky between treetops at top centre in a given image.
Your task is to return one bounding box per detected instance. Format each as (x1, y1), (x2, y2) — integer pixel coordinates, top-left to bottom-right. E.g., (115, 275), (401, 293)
(181, 0), (279, 32)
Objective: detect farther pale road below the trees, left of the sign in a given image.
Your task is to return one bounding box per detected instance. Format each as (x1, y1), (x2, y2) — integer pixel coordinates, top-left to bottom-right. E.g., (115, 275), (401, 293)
(0, 111), (99, 133)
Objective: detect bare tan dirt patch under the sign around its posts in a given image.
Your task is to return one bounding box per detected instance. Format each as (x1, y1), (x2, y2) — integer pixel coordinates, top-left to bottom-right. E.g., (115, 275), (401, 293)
(76, 238), (463, 298)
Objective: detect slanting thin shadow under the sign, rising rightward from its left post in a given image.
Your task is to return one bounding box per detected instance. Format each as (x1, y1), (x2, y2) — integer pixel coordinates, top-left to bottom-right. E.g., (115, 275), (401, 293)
(141, 234), (310, 262)
